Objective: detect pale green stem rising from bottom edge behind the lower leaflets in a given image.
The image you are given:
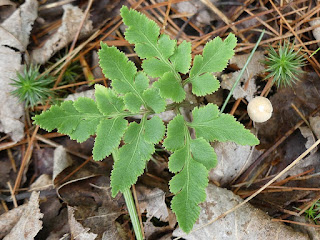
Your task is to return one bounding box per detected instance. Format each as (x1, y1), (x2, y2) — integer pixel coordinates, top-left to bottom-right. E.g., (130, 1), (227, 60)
(112, 149), (143, 240)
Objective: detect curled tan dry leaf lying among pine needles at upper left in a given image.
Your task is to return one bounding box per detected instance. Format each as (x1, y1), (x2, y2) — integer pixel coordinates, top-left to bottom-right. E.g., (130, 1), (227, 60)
(32, 4), (92, 64)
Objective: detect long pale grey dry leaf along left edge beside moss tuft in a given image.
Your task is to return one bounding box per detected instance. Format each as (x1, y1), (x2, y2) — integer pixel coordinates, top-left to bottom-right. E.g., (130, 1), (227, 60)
(0, 0), (38, 142)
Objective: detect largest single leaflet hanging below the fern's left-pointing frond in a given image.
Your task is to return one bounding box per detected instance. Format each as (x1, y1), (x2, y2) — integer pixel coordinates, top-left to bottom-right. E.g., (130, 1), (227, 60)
(92, 117), (128, 161)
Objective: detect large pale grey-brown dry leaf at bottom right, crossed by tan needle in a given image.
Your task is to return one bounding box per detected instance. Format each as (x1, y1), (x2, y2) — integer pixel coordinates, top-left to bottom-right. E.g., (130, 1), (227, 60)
(173, 184), (309, 240)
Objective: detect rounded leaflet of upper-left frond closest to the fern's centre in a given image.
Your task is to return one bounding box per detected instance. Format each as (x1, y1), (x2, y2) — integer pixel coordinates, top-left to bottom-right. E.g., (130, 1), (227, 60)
(143, 88), (166, 113)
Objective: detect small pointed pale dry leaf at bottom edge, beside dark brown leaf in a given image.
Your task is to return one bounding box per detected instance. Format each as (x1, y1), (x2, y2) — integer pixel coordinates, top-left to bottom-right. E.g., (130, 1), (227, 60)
(68, 206), (97, 240)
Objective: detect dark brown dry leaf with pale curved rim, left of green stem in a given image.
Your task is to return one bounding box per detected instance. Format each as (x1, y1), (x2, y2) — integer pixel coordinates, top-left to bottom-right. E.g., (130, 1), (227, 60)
(58, 175), (124, 240)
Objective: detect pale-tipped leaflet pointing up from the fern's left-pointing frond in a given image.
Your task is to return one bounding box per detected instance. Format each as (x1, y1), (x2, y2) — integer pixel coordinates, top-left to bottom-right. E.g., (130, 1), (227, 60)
(94, 84), (124, 116)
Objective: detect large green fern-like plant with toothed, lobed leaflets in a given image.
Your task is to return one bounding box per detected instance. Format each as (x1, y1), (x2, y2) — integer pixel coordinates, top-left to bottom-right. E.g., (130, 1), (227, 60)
(33, 6), (259, 233)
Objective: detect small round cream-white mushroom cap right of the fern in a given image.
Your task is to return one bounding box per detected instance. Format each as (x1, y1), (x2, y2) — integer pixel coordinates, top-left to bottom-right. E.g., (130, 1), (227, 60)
(248, 97), (273, 123)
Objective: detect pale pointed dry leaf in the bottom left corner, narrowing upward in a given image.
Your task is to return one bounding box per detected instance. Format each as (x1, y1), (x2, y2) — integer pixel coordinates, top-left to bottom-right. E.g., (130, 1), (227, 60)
(4, 192), (43, 240)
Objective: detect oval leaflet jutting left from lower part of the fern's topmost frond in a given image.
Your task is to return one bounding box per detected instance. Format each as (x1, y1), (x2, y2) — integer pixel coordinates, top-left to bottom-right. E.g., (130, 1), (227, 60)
(142, 58), (171, 77)
